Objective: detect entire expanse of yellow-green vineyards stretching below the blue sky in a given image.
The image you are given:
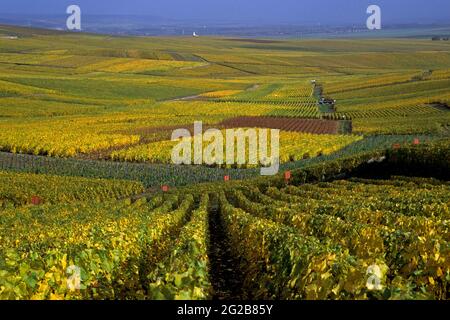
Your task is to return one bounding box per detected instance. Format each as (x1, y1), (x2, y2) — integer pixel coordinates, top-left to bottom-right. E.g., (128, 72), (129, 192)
(0, 26), (450, 300)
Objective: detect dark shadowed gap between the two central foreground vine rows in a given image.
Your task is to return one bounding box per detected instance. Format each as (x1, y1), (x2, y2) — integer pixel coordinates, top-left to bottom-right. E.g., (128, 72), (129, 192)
(208, 198), (246, 300)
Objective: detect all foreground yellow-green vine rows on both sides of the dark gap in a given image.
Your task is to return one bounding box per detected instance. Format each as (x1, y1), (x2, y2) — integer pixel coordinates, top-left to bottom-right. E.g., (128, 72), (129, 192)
(0, 144), (450, 299)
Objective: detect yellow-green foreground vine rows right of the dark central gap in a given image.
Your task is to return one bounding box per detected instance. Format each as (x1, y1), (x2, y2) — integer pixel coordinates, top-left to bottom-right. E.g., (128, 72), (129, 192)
(217, 179), (450, 299)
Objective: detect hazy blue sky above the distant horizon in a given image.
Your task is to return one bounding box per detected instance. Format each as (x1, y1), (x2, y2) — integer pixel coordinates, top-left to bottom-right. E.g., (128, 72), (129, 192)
(0, 0), (450, 24)
